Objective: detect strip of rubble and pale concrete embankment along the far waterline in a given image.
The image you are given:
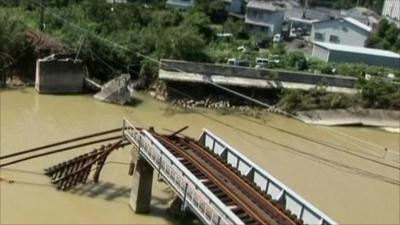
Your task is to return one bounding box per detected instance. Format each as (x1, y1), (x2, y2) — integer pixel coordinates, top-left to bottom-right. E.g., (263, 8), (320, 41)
(149, 92), (400, 133)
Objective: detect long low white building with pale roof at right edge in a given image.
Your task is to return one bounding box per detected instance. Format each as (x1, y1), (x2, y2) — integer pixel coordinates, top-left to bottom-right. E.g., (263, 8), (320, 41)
(312, 42), (400, 68)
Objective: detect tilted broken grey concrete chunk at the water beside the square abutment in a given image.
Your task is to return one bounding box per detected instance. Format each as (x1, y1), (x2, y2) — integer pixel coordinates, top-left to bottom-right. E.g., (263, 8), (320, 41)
(94, 74), (133, 105)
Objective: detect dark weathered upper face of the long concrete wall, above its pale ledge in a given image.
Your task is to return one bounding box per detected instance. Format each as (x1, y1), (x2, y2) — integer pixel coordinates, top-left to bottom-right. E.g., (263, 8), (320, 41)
(160, 59), (357, 88)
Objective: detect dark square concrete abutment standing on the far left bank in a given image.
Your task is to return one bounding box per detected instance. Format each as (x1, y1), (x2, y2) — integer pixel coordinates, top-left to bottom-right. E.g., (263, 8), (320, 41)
(35, 59), (87, 94)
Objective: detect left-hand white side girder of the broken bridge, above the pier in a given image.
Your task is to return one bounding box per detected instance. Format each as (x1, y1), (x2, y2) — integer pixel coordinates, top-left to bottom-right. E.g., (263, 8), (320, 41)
(123, 119), (244, 225)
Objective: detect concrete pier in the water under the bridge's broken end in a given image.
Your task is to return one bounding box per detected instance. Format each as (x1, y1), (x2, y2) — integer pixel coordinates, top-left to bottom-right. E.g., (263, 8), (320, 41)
(129, 156), (153, 213)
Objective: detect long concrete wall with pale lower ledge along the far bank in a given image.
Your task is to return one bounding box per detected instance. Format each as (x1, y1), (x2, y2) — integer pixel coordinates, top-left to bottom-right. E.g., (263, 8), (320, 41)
(158, 59), (357, 94)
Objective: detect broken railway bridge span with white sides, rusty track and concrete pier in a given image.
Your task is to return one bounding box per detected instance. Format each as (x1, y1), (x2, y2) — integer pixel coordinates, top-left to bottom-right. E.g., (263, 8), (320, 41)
(122, 120), (337, 225)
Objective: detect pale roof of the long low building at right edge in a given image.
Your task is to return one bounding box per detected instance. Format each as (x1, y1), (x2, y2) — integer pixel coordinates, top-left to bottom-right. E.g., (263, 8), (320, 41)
(313, 41), (400, 58)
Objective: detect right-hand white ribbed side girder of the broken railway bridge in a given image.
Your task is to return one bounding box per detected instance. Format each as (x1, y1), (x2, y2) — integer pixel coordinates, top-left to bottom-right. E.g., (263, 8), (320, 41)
(199, 129), (337, 225)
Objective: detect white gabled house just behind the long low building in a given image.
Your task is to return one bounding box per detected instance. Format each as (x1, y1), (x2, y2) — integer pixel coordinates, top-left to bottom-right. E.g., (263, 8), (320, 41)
(310, 17), (372, 47)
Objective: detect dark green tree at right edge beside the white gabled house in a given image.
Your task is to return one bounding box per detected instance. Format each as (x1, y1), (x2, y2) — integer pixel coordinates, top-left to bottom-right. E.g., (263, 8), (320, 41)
(367, 19), (400, 53)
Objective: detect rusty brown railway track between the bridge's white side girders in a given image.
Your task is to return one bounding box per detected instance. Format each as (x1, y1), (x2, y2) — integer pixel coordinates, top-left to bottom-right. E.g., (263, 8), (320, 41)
(152, 132), (303, 225)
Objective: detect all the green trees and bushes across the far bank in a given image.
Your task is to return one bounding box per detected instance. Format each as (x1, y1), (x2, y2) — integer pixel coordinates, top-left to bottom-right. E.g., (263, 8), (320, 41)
(0, 0), (400, 110)
